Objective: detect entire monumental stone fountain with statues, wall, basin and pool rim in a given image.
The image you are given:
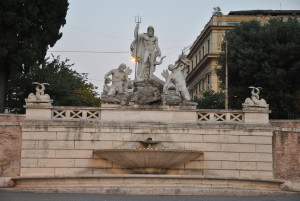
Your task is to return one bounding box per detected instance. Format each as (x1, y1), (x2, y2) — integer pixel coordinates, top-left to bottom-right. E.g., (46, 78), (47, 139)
(8, 19), (282, 194)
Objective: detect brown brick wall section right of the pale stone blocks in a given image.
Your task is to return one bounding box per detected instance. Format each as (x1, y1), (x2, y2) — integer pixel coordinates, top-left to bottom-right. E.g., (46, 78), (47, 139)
(271, 120), (300, 181)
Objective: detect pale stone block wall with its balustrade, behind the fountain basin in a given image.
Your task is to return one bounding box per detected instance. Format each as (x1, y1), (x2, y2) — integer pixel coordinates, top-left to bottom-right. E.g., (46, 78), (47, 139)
(21, 107), (273, 179)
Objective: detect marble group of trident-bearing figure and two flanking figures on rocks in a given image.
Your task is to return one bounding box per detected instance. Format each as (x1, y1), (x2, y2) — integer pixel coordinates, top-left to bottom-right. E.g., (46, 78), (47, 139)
(101, 23), (196, 106)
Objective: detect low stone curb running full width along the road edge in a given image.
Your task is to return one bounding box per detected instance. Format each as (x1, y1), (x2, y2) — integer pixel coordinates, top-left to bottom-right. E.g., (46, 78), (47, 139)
(2, 185), (300, 196)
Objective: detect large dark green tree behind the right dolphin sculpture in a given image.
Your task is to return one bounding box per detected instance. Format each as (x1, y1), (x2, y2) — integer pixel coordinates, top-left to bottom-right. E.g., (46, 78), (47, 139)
(216, 18), (300, 118)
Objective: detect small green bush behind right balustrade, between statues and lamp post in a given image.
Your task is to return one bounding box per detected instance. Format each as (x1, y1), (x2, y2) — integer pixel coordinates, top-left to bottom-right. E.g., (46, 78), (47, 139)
(193, 90), (225, 109)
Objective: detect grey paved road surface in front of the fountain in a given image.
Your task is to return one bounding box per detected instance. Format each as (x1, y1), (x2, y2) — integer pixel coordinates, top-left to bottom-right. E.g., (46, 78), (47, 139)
(0, 190), (300, 201)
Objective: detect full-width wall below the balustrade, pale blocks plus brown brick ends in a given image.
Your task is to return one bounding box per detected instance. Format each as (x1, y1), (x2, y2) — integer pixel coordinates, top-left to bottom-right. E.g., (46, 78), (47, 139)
(0, 112), (300, 183)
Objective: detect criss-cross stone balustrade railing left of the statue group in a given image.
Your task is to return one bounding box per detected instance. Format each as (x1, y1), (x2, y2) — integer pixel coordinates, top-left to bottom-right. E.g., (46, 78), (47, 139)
(52, 107), (101, 119)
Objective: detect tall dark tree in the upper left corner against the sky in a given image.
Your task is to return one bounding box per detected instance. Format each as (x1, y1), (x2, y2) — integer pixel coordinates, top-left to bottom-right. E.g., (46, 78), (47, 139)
(0, 0), (69, 113)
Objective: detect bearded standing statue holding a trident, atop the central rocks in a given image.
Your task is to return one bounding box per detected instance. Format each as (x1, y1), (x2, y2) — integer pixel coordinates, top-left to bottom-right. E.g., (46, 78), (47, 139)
(130, 17), (164, 81)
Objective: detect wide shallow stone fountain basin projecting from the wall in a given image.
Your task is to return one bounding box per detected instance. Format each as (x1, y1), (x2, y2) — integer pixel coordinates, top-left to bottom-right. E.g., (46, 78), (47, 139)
(94, 148), (203, 168)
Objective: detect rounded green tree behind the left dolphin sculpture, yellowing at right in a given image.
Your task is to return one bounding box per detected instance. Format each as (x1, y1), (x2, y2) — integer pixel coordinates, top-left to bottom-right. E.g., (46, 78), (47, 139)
(6, 57), (100, 111)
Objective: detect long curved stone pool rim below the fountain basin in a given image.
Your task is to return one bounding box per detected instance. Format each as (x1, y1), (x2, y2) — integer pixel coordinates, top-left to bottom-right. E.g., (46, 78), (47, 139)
(11, 174), (284, 195)
